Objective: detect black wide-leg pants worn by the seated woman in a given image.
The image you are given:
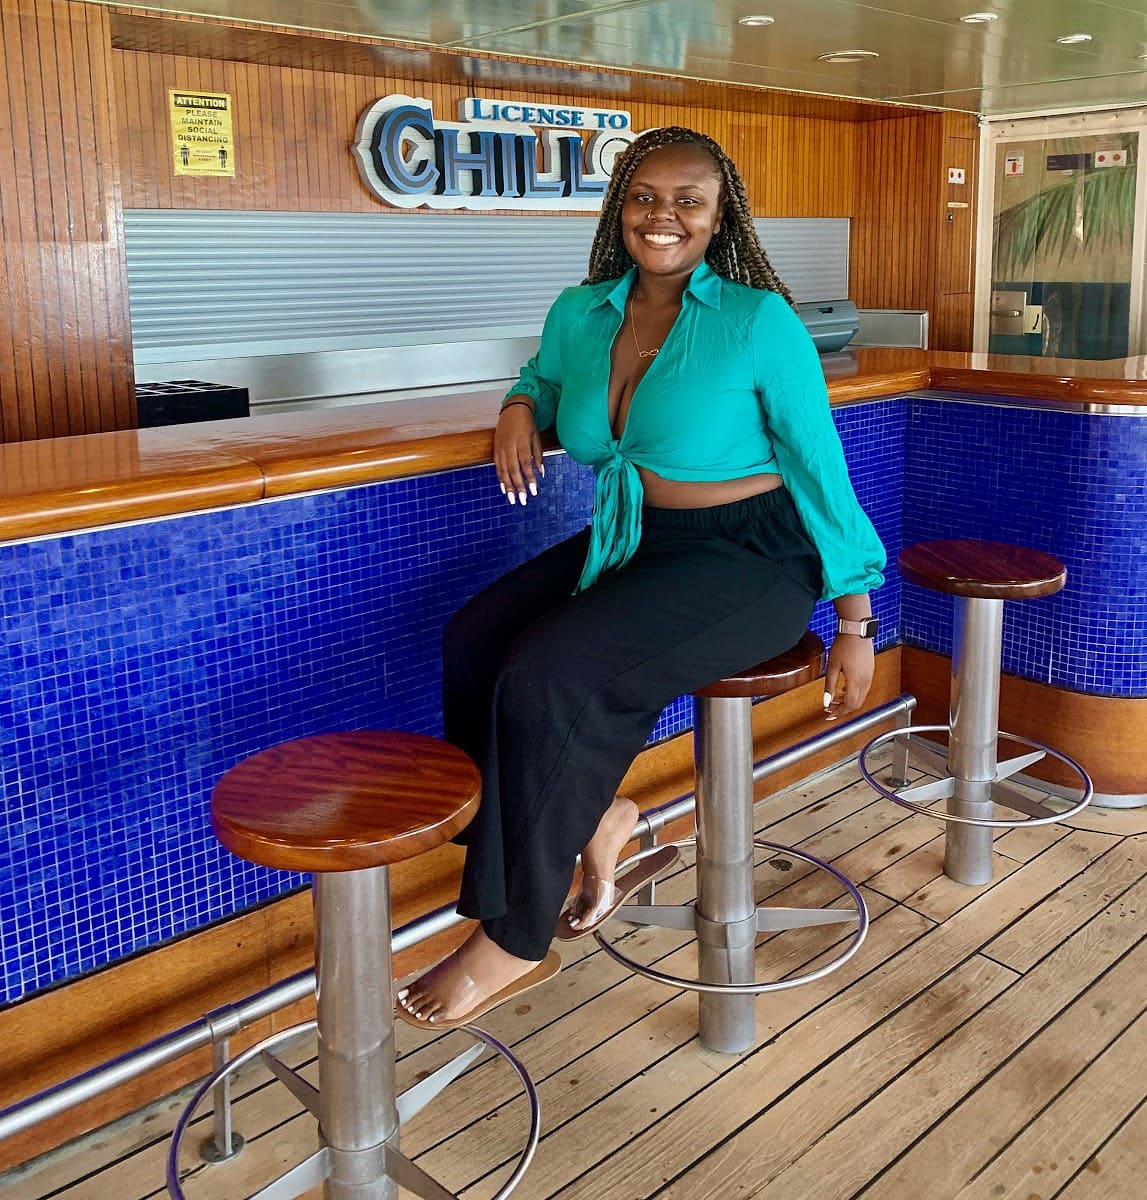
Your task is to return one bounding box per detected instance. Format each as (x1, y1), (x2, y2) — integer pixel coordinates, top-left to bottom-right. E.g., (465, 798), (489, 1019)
(443, 488), (821, 961)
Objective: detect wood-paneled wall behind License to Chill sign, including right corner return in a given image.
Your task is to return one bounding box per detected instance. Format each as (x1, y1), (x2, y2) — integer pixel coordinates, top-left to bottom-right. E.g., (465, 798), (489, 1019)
(115, 38), (975, 349)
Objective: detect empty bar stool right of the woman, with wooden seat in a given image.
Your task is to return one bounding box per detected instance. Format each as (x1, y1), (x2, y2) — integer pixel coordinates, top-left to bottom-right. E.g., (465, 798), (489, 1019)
(859, 540), (1093, 884)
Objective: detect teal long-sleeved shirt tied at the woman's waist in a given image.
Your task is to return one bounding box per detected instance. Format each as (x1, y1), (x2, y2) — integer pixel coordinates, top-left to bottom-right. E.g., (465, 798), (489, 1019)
(506, 263), (885, 599)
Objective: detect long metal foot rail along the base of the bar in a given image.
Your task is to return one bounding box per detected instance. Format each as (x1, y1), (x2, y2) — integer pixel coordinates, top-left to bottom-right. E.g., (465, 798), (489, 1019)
(0, 694), (917, 1141)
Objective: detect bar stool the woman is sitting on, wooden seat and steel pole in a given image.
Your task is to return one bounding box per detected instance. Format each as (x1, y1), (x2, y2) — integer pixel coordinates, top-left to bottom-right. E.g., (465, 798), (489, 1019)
(594, 630), (869, 1054)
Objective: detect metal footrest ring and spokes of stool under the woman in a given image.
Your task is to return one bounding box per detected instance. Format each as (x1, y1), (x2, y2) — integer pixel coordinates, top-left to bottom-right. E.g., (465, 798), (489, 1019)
(594, 839), (869, 996)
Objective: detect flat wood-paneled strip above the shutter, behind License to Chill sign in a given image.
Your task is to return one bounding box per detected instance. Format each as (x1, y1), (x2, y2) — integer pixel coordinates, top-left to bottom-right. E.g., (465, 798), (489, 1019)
(113, 50), (858, 221)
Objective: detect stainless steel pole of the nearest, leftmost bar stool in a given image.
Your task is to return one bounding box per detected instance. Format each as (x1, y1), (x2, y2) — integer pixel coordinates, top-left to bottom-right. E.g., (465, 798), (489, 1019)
(314, 866), (398, 1200)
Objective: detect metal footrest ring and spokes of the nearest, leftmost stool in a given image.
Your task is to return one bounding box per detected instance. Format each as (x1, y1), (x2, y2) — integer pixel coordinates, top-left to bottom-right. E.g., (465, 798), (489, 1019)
(167, 1020), (541, 1200)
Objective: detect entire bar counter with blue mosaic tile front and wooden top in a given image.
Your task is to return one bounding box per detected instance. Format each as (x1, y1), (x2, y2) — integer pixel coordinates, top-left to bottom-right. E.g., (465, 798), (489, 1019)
(0, 349), (1147, 1165)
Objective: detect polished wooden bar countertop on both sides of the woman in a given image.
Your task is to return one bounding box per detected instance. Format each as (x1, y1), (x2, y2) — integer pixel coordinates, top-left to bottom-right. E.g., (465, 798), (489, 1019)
(0, 349), (1147, 541)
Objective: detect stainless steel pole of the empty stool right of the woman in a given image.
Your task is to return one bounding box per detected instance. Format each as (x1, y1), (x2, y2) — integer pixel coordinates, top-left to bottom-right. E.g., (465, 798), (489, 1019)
(944, 596), (1004, 886)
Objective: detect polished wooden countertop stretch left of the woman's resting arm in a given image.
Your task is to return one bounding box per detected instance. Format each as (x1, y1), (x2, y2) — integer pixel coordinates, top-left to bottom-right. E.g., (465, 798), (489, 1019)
(0, 391), (502, 541)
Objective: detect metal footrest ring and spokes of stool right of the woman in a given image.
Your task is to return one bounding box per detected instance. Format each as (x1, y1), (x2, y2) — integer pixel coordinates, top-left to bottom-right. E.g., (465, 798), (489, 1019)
(857, 725), (1094, 829)
